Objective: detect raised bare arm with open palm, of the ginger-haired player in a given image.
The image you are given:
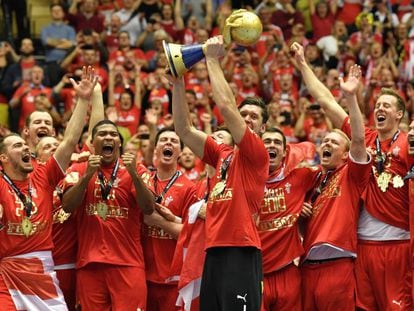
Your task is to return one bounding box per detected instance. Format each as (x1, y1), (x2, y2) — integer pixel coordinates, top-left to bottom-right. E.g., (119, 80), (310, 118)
(339, 65), (367, 162)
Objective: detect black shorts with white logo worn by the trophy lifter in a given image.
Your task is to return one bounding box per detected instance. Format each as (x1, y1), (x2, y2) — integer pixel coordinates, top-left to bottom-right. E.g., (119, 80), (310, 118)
(200, 247), (263, 311)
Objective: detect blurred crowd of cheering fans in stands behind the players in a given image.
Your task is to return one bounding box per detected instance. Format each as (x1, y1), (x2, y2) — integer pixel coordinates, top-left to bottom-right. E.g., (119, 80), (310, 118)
(0, 0), (414, 169)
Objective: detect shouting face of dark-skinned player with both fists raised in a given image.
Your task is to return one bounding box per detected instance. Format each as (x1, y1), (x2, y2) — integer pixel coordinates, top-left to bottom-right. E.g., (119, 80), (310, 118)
(92, 124), (121, 164)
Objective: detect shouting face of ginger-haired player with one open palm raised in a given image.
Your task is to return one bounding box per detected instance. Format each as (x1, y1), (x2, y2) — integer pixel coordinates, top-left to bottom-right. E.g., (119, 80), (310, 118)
(320, 132), (348, 170)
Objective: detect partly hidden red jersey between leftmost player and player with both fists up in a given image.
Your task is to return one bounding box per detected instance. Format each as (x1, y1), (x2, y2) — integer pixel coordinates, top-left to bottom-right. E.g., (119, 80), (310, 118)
(52, 183), (78, 266)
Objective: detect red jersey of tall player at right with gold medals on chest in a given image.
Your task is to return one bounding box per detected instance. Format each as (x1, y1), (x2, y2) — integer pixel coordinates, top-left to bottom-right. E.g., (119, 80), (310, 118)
(342, 118), (412, 231)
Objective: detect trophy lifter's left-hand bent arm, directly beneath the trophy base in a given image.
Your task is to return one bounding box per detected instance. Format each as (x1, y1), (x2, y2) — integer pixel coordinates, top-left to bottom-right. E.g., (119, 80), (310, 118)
(170, 77), (207, 159)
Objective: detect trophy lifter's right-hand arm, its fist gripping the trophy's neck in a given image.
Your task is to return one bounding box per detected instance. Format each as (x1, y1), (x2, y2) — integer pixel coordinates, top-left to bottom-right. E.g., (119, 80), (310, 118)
(205, 36), (247, 144)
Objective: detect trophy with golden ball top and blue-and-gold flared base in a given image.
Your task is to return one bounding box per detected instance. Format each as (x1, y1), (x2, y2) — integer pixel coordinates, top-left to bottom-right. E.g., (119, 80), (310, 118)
(162, 9), (263, 78)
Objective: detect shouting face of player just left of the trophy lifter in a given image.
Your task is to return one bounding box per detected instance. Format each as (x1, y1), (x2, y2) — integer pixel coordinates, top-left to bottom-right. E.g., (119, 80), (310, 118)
(155, 131), (181, 165)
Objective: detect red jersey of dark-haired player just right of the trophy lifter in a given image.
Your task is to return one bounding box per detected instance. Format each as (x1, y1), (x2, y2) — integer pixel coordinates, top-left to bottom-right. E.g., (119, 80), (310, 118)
(258, 168), (319, 273)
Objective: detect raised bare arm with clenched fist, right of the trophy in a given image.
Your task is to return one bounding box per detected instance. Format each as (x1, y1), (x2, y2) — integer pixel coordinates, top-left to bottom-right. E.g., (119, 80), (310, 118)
(290, 42), (347, 128)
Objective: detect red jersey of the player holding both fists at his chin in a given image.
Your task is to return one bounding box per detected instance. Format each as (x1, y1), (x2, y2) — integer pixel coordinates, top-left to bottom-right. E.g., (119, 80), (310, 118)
(63, 161), (144, 269)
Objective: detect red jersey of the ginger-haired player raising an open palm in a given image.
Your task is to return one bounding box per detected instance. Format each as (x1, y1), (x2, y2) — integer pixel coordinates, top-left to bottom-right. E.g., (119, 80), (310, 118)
(303, 159), (371, 255)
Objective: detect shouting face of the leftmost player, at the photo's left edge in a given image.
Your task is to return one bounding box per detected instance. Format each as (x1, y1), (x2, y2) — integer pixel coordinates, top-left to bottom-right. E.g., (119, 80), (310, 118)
(0, 136), (33, 174)
